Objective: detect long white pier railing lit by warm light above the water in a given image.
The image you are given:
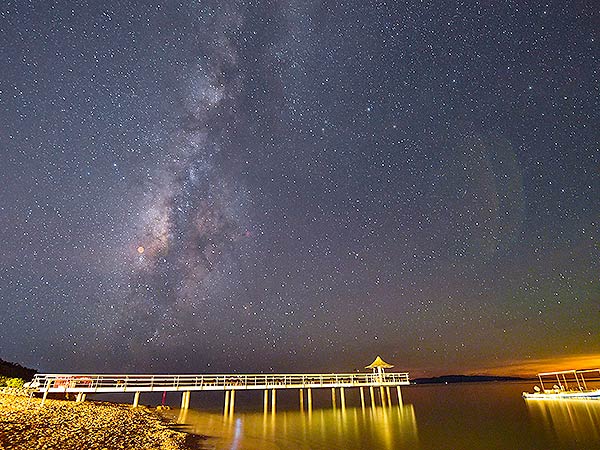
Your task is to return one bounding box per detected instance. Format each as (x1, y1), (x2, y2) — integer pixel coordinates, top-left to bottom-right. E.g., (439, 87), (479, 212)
(29, 372), (409, 393)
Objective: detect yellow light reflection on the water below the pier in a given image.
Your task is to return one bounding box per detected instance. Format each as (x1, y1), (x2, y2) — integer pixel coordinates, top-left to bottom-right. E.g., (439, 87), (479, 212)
(173, 405), (418, 450)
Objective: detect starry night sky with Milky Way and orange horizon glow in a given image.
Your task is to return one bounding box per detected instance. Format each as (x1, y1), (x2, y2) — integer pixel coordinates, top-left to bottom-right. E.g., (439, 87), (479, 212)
(0, 0), (600, 376)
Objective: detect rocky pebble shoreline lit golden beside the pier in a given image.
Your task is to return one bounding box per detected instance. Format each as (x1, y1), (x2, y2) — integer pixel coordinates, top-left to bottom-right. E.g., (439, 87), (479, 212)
(0, 393), (202, 450)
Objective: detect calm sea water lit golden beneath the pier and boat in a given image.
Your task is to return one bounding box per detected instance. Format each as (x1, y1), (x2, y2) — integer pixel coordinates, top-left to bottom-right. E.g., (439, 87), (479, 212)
(162, 383), (600, 450)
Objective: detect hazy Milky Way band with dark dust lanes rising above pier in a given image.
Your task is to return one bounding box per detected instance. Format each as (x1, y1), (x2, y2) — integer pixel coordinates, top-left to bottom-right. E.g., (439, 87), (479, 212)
(105, 3), (251, 366)
